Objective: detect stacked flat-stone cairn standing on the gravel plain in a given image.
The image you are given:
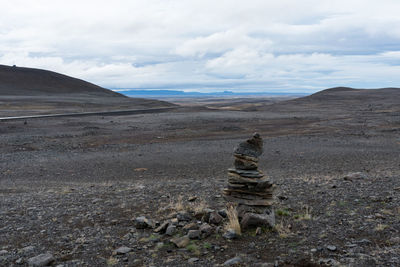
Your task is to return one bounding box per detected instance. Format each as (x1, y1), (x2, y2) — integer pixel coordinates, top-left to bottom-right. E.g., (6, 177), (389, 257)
(224, 133), (275, 229)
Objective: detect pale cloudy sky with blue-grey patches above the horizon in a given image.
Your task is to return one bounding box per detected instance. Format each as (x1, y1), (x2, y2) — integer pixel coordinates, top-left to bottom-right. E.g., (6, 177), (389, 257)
(0, 0), (400, 92)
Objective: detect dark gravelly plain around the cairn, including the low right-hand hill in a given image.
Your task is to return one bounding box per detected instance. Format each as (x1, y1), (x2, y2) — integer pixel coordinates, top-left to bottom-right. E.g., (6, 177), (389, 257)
(0, 88), (400, 266)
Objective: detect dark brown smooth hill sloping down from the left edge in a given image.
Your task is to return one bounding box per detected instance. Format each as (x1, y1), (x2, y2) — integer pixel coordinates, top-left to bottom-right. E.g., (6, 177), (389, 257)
(0, 65), (125, 97)
